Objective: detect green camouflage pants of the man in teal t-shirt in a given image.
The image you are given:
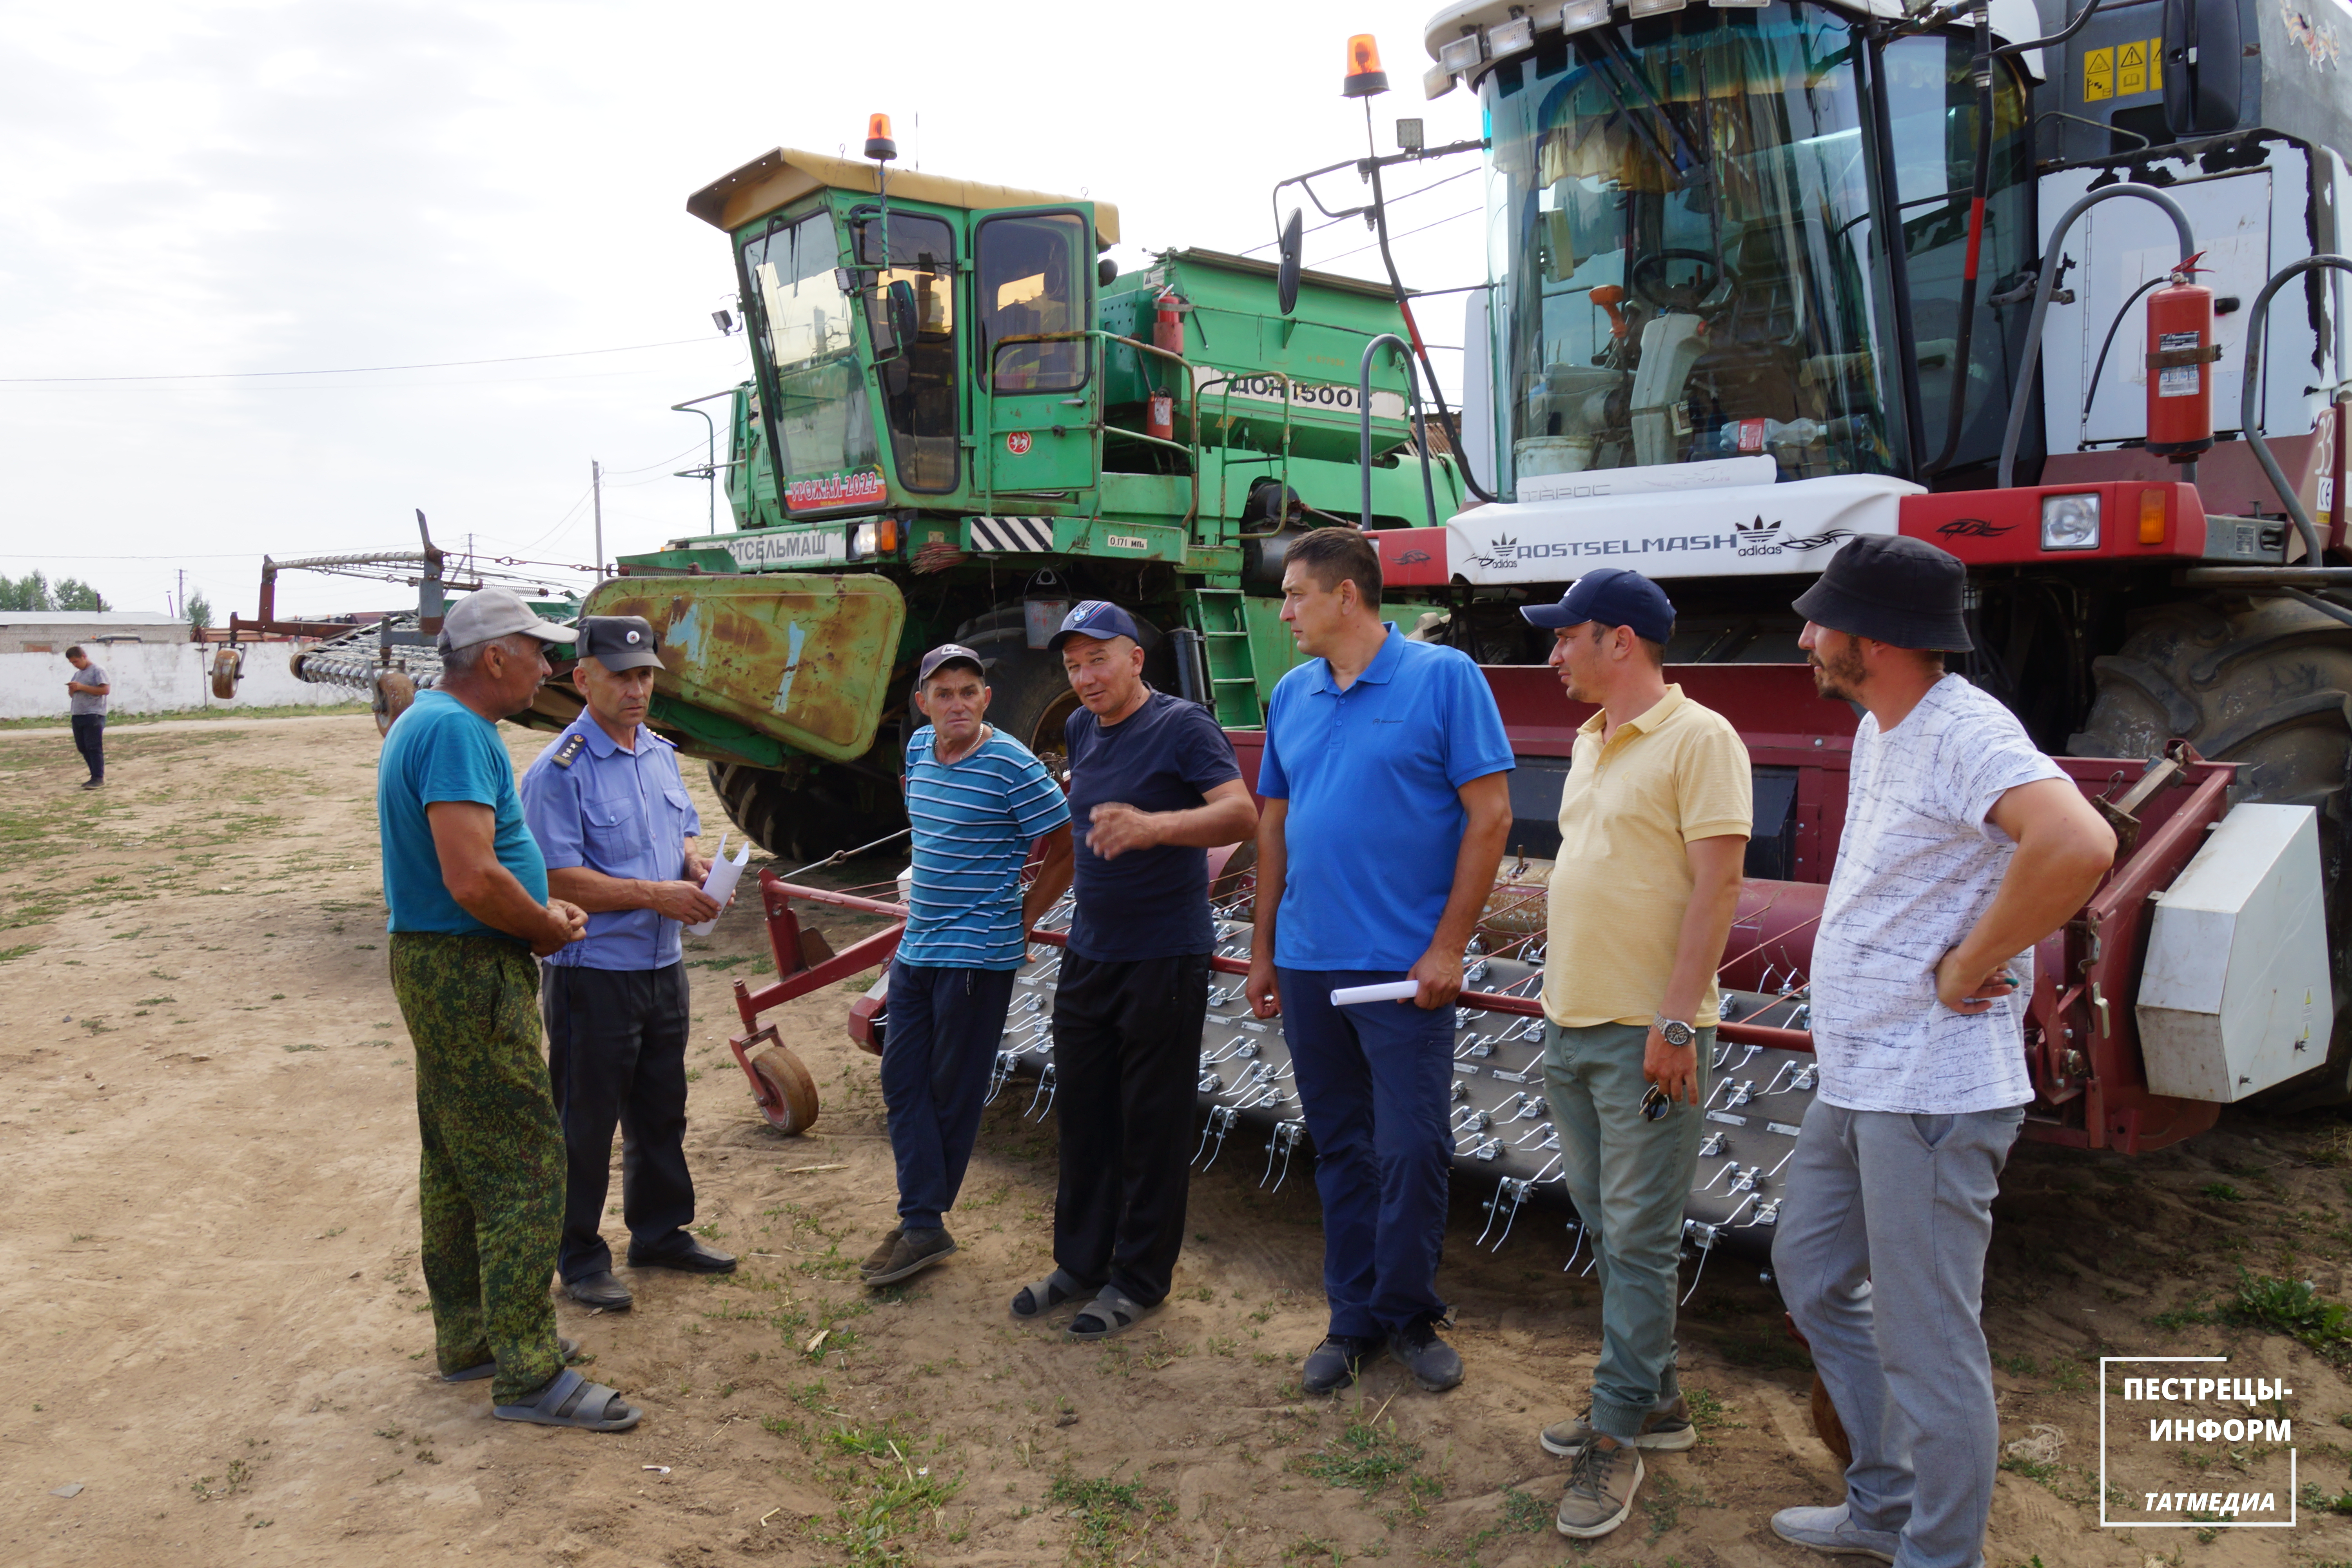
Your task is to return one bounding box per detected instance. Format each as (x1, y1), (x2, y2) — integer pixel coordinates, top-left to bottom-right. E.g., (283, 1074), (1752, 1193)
(390, 931), (564, 1403)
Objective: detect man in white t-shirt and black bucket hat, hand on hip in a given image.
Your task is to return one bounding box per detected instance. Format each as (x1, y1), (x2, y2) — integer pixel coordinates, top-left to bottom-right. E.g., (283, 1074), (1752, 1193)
(1771, 538), (2114, 1568)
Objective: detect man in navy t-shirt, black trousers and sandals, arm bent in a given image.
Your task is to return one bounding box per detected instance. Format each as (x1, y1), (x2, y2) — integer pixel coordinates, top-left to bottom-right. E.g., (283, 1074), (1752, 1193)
(1014, 599), (1258, 1340)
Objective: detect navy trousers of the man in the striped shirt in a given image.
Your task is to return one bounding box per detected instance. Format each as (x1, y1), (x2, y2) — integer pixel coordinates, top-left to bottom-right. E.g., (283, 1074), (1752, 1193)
(882, 959), (1014, 1229)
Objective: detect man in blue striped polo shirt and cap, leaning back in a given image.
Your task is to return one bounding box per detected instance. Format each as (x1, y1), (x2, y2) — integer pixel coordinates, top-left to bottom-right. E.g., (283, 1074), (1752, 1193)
(861, 642), (1070, 1286)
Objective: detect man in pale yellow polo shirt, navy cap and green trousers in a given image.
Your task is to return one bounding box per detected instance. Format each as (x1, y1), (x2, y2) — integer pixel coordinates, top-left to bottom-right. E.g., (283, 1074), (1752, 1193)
(1519, 566), (1755, 1540)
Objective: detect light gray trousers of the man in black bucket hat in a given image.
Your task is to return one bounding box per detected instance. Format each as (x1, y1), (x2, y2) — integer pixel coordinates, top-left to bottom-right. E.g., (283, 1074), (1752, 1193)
(1771, 1100), (2025, 1568)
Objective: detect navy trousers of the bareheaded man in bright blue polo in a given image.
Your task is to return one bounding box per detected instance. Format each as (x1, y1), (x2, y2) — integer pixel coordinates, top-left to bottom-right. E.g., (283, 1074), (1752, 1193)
(1275, 969), (1454, 1338)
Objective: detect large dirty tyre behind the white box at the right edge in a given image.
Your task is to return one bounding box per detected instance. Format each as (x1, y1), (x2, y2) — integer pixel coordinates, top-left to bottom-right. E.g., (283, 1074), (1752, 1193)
(2067, 597), (2352, 1110)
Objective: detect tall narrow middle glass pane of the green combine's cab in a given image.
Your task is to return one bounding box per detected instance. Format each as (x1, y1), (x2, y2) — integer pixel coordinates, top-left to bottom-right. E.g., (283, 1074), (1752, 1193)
(851, 209), (957, 494)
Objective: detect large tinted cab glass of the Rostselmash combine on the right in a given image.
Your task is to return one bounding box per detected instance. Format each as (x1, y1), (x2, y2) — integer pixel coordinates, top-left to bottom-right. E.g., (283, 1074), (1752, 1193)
(1484, 2), (2023, 494)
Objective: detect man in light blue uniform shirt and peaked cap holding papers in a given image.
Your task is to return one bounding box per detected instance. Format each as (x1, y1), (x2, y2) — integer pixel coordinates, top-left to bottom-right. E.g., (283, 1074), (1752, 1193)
(522, 616), (736, 1312)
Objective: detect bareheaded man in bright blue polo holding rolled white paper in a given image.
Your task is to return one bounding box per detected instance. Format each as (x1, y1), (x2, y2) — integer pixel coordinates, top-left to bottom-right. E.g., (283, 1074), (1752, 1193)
(1247, 529), (1512, 1394)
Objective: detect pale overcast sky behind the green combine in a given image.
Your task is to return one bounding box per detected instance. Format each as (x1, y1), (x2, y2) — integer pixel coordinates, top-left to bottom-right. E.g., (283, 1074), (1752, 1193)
(0, 0), (1482, 621)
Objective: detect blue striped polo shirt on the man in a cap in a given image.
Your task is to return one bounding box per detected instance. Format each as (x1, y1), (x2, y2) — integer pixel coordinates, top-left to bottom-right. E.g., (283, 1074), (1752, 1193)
(898, 724), (1070, 969)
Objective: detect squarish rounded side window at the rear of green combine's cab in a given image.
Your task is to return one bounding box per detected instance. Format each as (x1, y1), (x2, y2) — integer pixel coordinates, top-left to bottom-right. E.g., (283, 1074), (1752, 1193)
(974, 212), (1094, 392)
